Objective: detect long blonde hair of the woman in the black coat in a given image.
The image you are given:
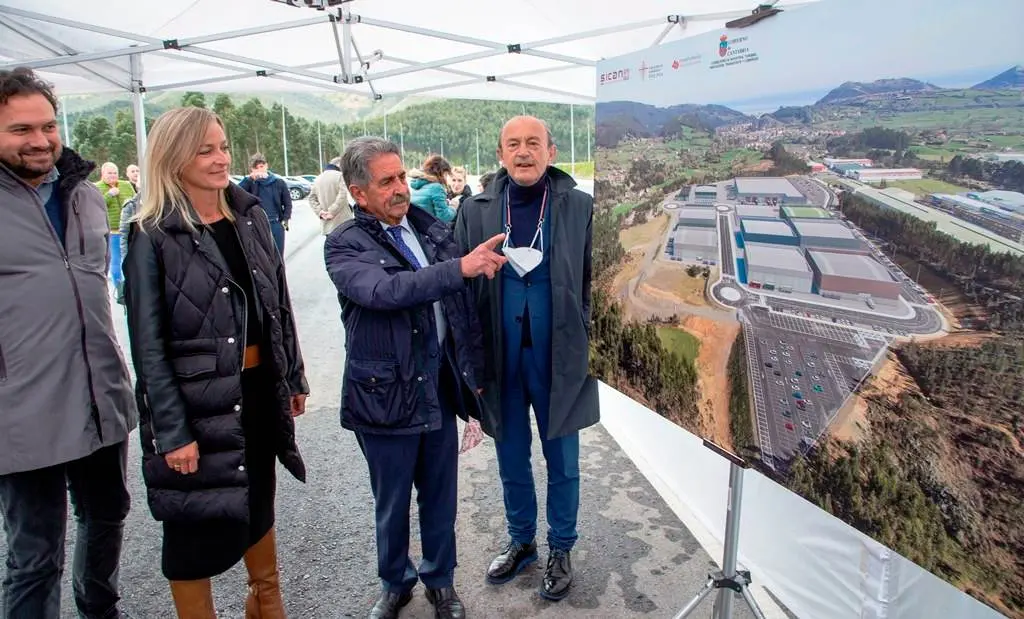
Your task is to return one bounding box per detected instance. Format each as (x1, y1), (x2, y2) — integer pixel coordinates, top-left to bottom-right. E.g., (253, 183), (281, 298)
(135, 106), (233, 230)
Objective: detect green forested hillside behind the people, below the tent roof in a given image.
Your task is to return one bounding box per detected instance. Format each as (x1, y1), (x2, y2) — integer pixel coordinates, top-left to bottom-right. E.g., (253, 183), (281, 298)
(67, 92), (594, 174)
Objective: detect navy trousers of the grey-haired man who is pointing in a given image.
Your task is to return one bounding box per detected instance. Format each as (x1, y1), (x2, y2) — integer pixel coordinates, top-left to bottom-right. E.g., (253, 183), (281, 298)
(356, 399), (459, 593)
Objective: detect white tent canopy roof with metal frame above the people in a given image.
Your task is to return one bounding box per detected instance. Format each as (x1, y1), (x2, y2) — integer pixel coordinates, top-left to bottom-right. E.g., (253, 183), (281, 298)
(0, 0), (806, 102)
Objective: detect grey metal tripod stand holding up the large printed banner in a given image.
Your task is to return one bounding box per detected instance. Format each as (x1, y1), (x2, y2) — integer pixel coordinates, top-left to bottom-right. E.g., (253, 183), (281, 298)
(675, 440), (765, 619)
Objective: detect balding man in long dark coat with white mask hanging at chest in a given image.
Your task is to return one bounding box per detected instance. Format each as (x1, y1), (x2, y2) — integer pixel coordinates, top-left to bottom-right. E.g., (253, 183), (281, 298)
(456, 116), (599, 600)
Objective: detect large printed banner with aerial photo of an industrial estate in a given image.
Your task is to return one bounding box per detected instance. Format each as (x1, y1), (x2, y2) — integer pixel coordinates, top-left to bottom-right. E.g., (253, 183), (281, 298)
(595, 0), (1024, 617)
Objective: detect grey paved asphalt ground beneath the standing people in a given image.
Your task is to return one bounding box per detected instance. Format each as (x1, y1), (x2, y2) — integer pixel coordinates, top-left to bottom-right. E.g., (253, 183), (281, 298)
(0, 205), (774, 619)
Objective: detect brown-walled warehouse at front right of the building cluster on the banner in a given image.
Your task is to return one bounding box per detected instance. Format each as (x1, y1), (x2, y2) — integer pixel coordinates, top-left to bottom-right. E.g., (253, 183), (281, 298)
(807, 249), (900, 302)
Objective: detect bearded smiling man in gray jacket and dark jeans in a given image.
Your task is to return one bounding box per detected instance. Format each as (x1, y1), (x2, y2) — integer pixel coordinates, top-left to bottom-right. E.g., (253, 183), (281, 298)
(0, 69), (137, 619)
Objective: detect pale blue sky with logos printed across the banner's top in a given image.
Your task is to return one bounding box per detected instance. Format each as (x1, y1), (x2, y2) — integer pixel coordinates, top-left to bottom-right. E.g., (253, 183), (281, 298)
(597, 0), (1024, 112)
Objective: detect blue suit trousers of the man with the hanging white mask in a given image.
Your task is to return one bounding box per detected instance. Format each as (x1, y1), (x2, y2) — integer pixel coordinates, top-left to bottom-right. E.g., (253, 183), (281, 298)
(496, 346), (580, 550)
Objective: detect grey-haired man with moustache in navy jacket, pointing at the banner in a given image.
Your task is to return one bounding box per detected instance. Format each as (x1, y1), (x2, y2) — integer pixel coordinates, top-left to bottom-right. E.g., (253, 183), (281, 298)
(324, 137), (504, 619)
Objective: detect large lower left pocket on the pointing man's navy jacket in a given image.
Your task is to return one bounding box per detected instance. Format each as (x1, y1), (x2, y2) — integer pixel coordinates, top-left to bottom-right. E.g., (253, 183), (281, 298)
(344, 359), (401, 427)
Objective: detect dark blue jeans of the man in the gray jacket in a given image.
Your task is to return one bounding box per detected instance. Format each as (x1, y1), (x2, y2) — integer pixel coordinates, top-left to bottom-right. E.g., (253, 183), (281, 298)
(0, 441), (131, 619)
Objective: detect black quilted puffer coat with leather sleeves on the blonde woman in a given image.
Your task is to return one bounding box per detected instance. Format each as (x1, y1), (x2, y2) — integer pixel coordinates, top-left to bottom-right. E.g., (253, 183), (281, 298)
(124, 183), (309, 522)
